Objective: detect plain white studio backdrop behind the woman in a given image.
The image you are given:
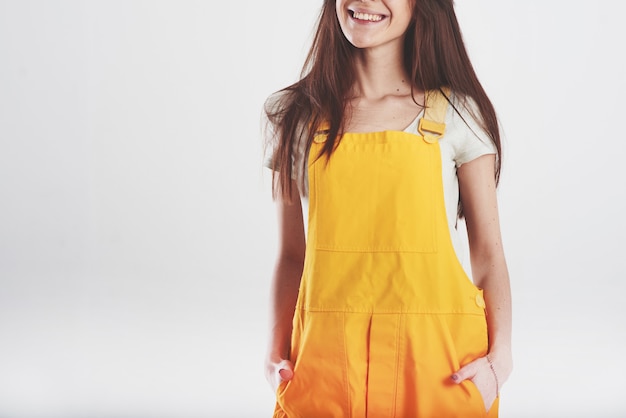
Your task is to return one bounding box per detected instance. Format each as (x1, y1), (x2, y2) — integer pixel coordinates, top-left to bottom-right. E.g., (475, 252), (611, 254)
(0, 0), (626, 418)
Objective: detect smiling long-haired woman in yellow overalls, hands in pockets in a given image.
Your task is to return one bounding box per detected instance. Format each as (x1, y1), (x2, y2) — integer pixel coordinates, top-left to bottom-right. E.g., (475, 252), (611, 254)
(266, 0), (512, 418)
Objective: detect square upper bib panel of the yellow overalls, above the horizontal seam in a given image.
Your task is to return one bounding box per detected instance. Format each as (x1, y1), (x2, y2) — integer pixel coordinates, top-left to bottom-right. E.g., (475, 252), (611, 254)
(309, 132), (438, 253)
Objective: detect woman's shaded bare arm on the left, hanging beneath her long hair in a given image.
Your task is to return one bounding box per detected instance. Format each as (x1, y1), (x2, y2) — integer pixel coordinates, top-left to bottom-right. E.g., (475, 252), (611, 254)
(265, 182), (306, 391)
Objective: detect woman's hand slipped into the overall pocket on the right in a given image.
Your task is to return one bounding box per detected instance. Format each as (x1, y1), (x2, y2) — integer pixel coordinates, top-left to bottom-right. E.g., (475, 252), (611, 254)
(452, 356), (510, 412)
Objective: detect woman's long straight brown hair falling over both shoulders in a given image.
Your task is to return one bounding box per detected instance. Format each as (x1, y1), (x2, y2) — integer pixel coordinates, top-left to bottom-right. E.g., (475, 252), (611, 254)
(265, 0), (501, 198)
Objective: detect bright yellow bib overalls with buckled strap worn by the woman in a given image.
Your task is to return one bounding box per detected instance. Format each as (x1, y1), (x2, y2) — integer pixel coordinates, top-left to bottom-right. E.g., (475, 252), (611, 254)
(274, 92), (498, 418)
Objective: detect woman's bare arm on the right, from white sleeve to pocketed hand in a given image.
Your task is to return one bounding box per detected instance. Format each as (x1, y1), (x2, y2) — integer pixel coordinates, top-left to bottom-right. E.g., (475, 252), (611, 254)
(457, 155), (513, 406)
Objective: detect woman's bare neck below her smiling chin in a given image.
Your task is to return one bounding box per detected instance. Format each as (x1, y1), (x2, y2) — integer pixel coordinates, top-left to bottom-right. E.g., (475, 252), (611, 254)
(353, 42), (411, 99)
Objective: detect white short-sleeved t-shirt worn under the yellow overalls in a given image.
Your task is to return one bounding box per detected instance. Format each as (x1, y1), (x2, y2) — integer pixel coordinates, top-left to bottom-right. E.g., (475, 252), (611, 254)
(264, 95), (496, 277)
